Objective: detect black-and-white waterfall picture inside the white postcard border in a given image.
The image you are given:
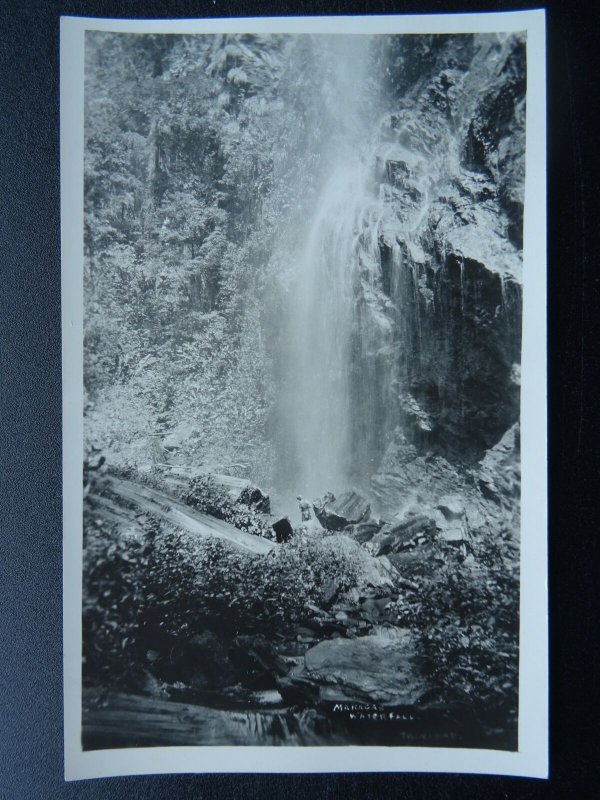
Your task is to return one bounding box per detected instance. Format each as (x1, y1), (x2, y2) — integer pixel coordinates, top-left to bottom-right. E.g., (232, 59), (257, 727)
(63, 9), (546, 774)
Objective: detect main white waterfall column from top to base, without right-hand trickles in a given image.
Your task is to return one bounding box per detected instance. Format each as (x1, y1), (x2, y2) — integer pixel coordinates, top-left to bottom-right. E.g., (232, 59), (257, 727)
(280, 37), (398, 497)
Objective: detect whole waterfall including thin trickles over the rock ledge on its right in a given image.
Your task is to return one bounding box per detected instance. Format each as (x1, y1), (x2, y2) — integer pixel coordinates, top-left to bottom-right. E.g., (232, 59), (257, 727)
(277, 36), (450, 498)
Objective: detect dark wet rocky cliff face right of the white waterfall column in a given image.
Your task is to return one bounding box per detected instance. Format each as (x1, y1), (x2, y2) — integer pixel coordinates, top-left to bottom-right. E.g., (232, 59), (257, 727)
(354, 35), (525, 482)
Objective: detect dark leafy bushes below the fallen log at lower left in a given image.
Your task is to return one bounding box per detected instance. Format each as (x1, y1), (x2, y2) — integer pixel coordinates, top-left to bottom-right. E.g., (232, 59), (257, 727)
(83, 514), (357, 687)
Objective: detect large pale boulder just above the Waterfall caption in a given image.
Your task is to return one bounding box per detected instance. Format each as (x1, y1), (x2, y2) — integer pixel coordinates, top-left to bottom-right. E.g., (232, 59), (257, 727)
(280, 634), (428, 707)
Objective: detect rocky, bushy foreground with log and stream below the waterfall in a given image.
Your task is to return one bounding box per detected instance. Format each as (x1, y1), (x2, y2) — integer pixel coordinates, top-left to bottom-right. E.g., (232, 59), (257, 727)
(84, 430), (518, 748)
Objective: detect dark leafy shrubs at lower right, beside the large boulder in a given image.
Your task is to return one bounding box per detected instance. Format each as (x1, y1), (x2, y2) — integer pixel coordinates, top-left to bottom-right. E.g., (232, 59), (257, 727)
(394, 537), (519, 714)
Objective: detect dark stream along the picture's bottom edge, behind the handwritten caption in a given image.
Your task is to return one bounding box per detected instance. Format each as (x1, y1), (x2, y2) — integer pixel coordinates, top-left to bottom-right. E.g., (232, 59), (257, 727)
(82, 688), (499, 750)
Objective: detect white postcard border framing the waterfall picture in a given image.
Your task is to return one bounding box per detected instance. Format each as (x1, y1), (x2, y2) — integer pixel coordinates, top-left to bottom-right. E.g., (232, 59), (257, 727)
(60, 10), (548, 780)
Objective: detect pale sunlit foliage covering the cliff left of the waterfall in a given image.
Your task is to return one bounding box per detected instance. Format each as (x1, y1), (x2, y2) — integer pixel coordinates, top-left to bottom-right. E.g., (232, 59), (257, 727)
(84, 32), (370, 483)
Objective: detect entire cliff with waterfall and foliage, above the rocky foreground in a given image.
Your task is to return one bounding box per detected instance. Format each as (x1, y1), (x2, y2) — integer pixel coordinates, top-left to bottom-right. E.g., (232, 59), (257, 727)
(85, 34), (525, 506)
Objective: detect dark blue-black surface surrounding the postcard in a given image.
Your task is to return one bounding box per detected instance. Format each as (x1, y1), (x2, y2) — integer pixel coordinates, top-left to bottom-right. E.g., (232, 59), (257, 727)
(0, 0), (600, 800)
